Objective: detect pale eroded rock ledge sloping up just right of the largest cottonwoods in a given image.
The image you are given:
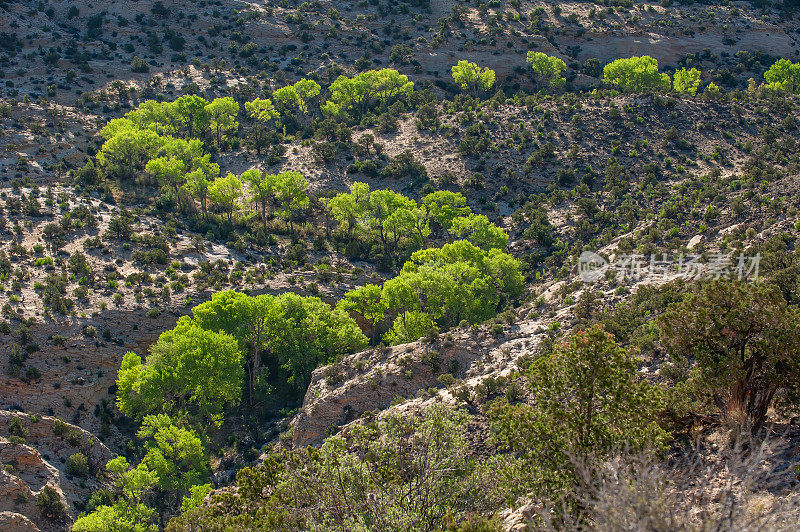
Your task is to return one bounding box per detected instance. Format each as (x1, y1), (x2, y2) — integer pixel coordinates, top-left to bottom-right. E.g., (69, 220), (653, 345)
(290, 300), (569, 448)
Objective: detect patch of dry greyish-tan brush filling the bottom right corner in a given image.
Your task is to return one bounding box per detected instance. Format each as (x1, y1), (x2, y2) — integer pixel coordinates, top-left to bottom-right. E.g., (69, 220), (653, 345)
(530, 433), (800, 532)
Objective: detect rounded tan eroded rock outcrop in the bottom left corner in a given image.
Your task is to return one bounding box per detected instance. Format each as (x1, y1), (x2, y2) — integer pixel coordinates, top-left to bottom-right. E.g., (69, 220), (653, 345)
(0, 411), (114, 532)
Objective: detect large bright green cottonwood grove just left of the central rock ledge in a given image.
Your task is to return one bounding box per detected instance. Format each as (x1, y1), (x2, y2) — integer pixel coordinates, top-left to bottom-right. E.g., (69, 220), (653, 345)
(117, 291), (367, 423)
